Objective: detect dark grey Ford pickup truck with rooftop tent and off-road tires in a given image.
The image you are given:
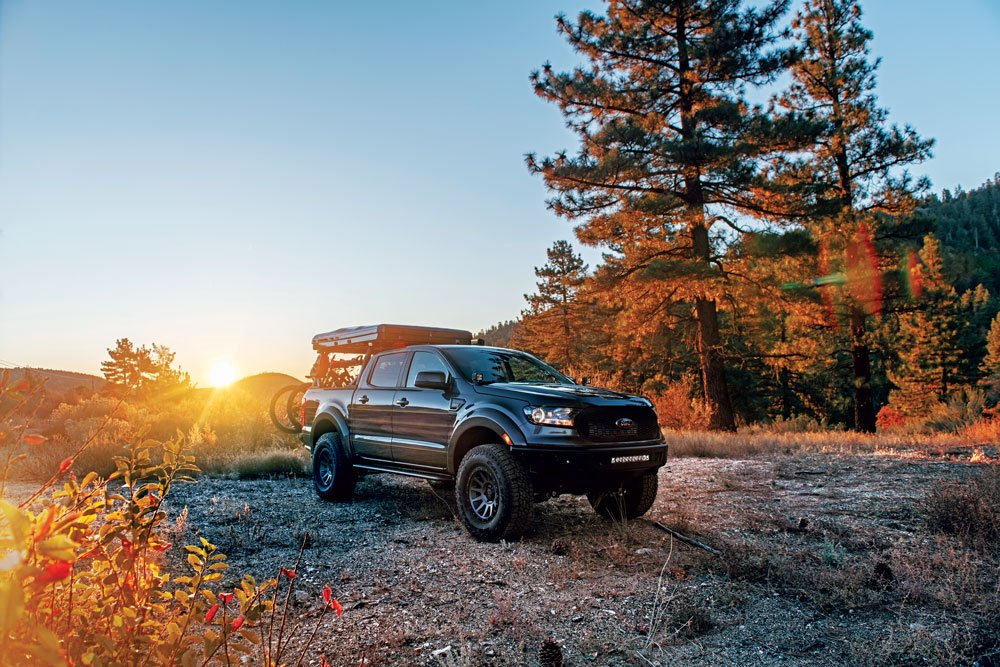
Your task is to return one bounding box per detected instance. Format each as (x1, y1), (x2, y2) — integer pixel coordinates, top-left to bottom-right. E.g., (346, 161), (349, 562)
(299, 325), (667, 541)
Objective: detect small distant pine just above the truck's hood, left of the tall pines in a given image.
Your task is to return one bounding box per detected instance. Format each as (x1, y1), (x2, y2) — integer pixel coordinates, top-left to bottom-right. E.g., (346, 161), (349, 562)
(515, 241), (587, 369)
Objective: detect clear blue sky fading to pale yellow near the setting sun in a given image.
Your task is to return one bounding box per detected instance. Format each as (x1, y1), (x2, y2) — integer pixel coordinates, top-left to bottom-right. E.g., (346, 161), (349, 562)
(0, 0), (1000, 383)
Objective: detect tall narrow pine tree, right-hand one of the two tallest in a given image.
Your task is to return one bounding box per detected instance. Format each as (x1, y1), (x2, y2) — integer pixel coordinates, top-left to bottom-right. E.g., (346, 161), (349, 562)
(775, 0), (932, 432)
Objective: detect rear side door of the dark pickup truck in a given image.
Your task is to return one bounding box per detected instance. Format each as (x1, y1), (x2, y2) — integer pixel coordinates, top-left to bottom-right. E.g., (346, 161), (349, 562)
(350, 352), (407, 461)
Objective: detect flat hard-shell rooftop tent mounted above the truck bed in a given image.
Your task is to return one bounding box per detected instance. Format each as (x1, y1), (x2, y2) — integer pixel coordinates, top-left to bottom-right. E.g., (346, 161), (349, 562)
(313, 324), (472, 354)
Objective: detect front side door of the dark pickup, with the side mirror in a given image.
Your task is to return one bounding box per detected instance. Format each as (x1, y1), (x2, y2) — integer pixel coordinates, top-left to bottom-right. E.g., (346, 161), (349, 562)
(392, 350), (460, 470)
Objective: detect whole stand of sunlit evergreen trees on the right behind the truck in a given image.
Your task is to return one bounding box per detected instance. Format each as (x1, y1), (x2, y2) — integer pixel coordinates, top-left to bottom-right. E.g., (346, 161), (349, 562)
(484, 0), (1000, 431)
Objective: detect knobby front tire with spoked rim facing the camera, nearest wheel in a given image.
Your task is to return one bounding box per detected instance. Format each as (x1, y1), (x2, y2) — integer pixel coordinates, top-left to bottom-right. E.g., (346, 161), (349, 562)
(455, 444), (534, 542)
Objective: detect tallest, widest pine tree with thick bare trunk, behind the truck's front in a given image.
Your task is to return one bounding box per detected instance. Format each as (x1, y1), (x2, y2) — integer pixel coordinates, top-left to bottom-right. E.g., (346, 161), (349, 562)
(528, 0), (788, 430)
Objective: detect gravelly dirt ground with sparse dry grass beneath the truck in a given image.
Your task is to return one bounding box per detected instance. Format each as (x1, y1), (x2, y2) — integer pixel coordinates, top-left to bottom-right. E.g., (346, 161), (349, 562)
(169, 454), (1000, 667)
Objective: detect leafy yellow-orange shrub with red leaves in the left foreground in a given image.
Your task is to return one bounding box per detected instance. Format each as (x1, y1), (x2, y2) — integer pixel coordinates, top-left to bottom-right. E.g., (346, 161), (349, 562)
(0, 377), (342, 666)
